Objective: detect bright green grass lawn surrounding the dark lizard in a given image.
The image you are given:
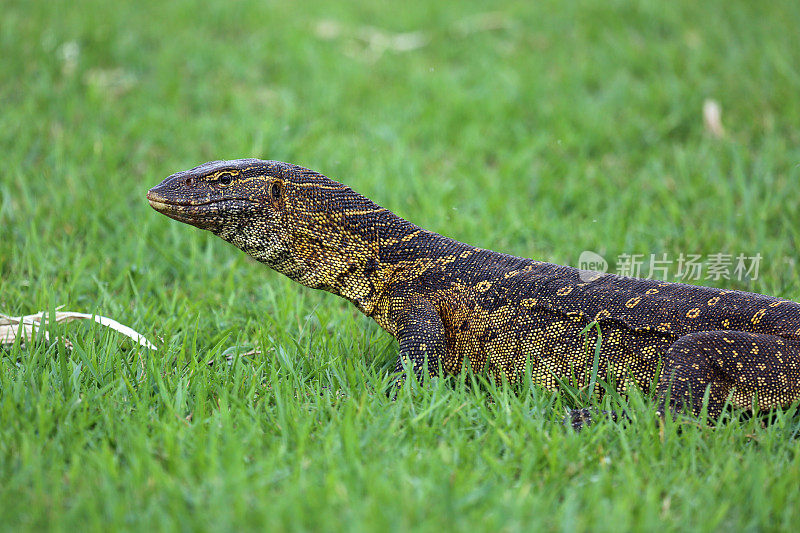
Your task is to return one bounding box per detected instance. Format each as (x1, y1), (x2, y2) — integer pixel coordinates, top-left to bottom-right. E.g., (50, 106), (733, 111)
(0, 0), (800, 531)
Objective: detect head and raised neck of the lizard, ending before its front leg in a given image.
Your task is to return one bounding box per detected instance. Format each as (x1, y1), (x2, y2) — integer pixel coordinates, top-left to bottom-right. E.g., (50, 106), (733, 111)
(147, 159), (396, 308)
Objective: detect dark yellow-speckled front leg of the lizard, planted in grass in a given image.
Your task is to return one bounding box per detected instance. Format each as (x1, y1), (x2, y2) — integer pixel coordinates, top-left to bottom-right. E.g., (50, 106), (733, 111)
(389, 299), (447, 395)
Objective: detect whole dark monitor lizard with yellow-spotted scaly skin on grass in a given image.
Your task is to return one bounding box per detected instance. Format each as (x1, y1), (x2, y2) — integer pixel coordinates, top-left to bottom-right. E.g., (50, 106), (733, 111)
(147, 159), (800, 425)
